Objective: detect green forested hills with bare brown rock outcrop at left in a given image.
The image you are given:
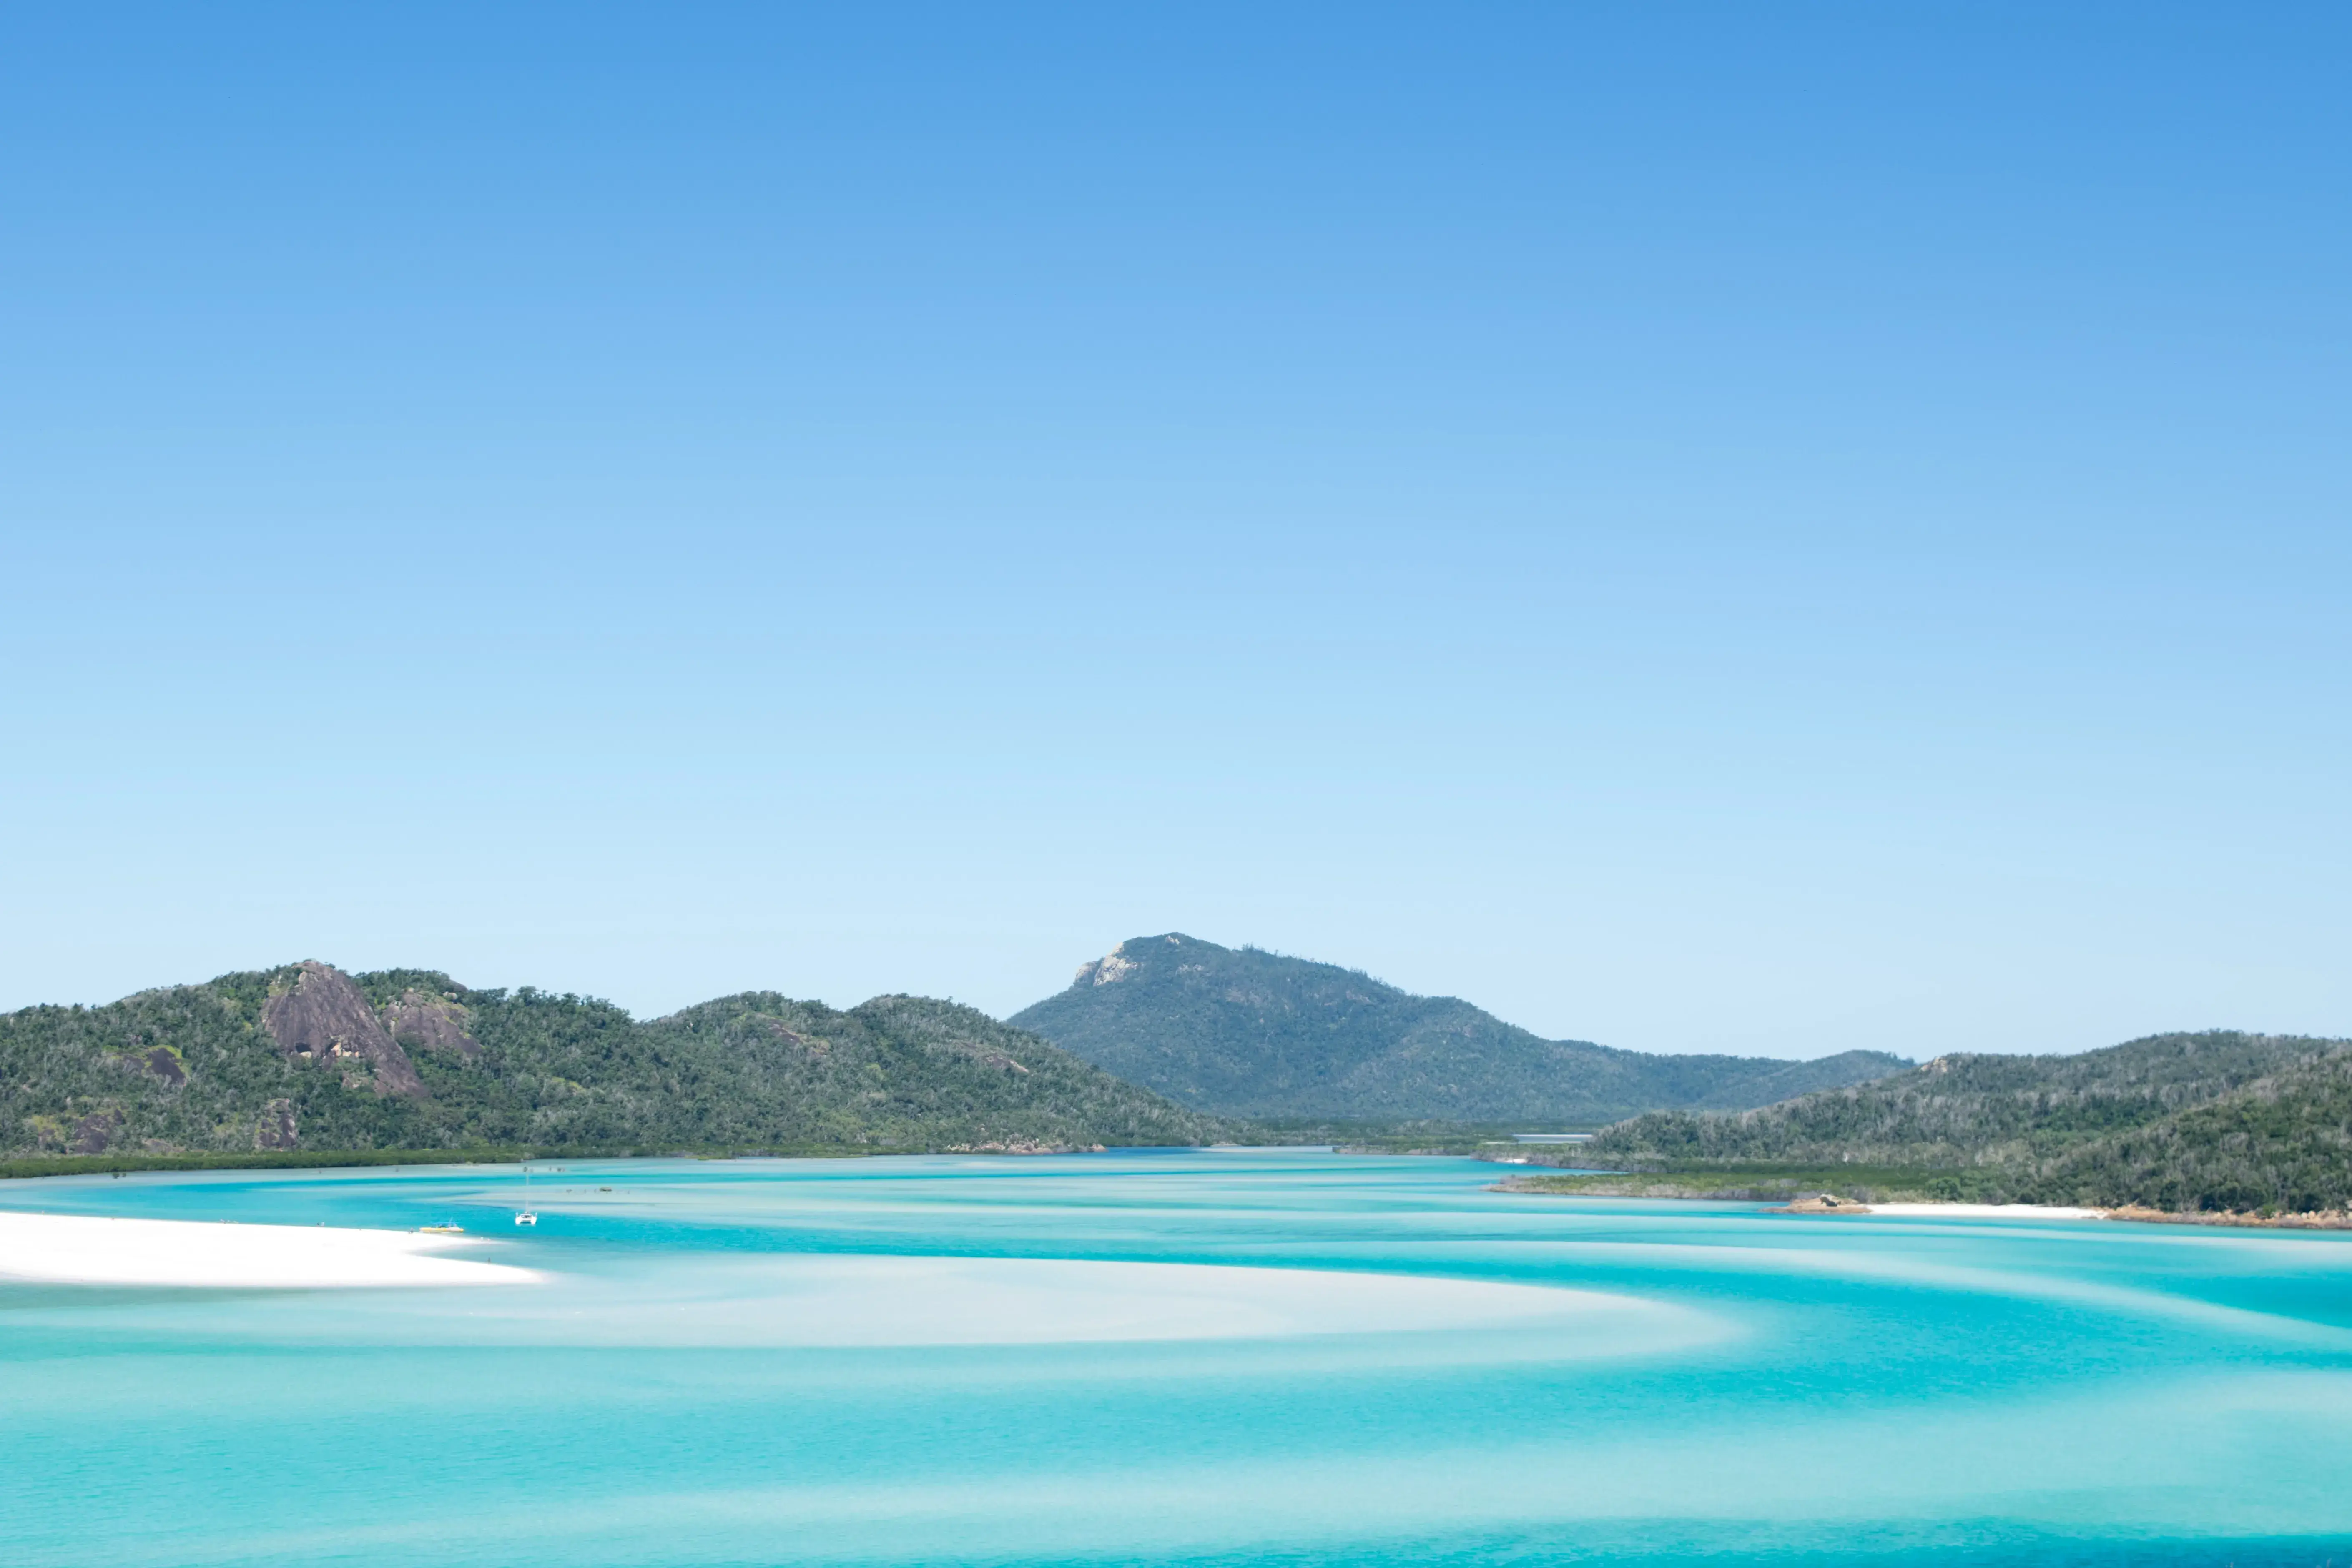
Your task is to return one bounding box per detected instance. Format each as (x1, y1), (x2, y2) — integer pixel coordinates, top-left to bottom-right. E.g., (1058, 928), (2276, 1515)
(0, 964), (1218, 1154)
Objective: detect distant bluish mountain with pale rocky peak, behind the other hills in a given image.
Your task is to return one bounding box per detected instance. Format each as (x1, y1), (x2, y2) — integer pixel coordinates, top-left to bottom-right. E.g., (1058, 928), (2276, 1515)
(1012, 936), (1910, 1126)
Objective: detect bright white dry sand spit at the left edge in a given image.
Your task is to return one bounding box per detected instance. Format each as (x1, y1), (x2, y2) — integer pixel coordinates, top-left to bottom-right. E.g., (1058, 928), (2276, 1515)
(0, 1211), (541, 1288)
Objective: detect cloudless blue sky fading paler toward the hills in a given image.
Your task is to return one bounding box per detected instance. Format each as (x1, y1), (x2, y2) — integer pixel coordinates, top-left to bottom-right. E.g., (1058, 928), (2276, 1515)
(0, 3), (2352, 1056)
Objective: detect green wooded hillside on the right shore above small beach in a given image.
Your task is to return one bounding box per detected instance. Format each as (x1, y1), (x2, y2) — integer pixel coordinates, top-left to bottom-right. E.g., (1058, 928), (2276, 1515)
(1578, 1030), (2352, 1213)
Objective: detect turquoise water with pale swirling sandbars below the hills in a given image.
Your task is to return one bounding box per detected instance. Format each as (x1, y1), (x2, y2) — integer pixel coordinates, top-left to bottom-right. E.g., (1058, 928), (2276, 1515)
(0, 1152), (2352, 1568)
